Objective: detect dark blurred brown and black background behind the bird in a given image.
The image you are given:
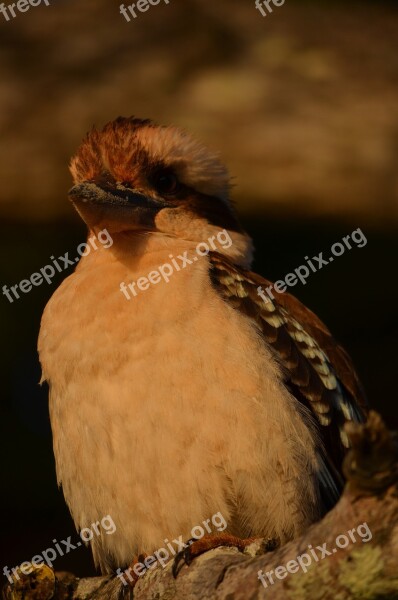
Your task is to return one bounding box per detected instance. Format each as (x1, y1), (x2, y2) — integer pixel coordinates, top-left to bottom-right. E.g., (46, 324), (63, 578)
(0, 0), (398, 575)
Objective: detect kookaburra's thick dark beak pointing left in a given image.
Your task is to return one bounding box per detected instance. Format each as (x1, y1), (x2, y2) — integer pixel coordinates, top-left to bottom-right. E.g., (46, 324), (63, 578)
(68, 182), (168, 232)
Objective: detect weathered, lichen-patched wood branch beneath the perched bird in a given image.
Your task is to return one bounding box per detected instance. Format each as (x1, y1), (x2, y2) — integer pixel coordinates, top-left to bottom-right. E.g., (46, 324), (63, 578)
(3, 412), (398, 600)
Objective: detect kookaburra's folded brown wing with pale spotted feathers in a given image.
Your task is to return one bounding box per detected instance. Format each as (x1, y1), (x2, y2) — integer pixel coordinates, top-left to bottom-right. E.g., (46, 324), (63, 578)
(210, 253), (367, 472)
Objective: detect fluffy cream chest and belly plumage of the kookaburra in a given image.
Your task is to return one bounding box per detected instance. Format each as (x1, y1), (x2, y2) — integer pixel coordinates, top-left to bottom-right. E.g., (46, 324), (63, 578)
(39, 243), (317, 570)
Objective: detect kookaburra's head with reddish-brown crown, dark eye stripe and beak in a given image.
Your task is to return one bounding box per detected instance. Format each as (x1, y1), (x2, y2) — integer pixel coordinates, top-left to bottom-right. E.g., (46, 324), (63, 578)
(69, 117), (252, 265)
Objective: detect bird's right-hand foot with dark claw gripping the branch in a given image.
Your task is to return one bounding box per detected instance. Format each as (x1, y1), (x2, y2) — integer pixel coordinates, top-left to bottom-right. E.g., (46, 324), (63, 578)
(172, 533), (257, 578)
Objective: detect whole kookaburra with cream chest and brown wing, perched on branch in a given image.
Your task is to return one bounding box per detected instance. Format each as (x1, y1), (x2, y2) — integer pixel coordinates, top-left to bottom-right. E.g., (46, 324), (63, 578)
(39, 118), (365, 572)
